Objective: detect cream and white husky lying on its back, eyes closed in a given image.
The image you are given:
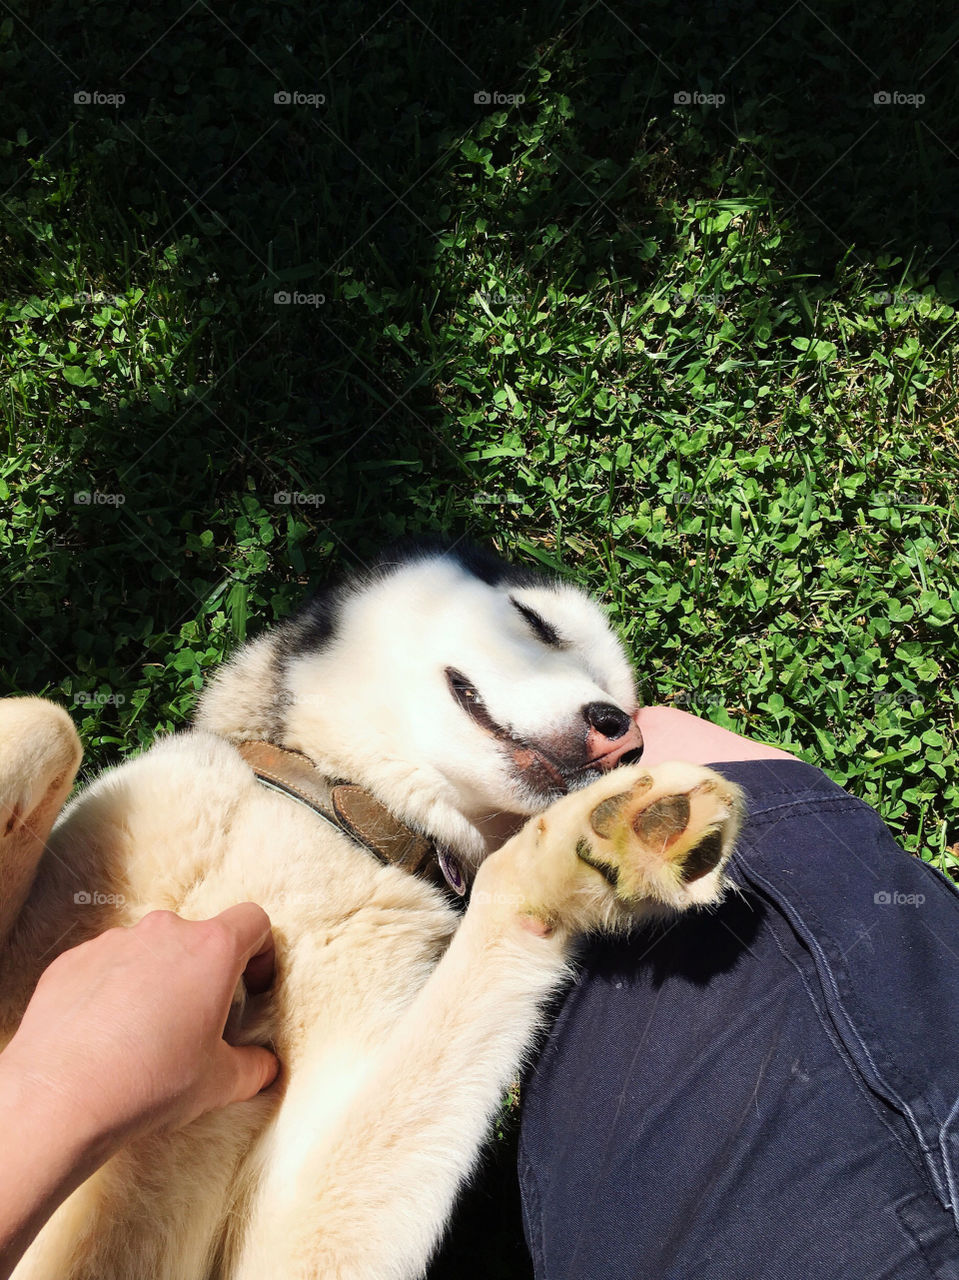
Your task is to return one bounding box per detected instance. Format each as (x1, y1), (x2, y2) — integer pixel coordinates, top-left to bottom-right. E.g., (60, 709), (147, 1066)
(0, 544), (741, 1280)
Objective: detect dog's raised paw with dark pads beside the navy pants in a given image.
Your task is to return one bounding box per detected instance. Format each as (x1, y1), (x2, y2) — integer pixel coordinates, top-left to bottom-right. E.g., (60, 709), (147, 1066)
(474, 763), (745, 933)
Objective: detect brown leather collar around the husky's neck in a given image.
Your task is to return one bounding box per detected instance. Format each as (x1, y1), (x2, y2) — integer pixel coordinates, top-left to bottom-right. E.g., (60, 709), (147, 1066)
(233, 741), (466, 897)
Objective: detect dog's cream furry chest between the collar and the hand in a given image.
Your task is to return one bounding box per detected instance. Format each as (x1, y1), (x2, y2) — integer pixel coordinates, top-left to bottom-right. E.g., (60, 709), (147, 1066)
(58, 735), (460, 1041)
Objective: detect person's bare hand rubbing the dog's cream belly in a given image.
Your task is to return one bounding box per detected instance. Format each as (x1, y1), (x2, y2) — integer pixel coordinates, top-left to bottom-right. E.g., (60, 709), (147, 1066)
(0, 902), (279, 1161)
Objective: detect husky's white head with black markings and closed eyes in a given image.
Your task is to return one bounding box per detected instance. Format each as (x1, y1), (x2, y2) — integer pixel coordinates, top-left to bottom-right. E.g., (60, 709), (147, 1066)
(200, 543), (643, 852)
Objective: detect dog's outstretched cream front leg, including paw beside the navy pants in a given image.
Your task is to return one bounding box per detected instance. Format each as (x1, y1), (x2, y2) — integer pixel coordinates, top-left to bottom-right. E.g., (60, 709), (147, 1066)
(233, 765), (740, 1280)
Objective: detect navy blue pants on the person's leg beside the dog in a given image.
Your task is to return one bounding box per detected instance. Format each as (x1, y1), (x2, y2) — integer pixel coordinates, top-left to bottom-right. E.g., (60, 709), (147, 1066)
(520, 760), (959, 1280)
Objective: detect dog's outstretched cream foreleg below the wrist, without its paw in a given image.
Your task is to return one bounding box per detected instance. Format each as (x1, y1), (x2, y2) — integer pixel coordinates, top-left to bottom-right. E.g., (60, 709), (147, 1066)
(233, 906), (567, 1280)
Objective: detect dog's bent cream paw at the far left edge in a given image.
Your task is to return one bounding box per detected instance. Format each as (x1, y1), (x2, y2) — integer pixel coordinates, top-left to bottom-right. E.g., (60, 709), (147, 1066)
(0, 698), (83, 943)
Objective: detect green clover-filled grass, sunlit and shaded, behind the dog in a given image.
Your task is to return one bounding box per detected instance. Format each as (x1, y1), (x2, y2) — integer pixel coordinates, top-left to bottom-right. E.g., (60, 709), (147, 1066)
(0, 0), (959, 1275)
